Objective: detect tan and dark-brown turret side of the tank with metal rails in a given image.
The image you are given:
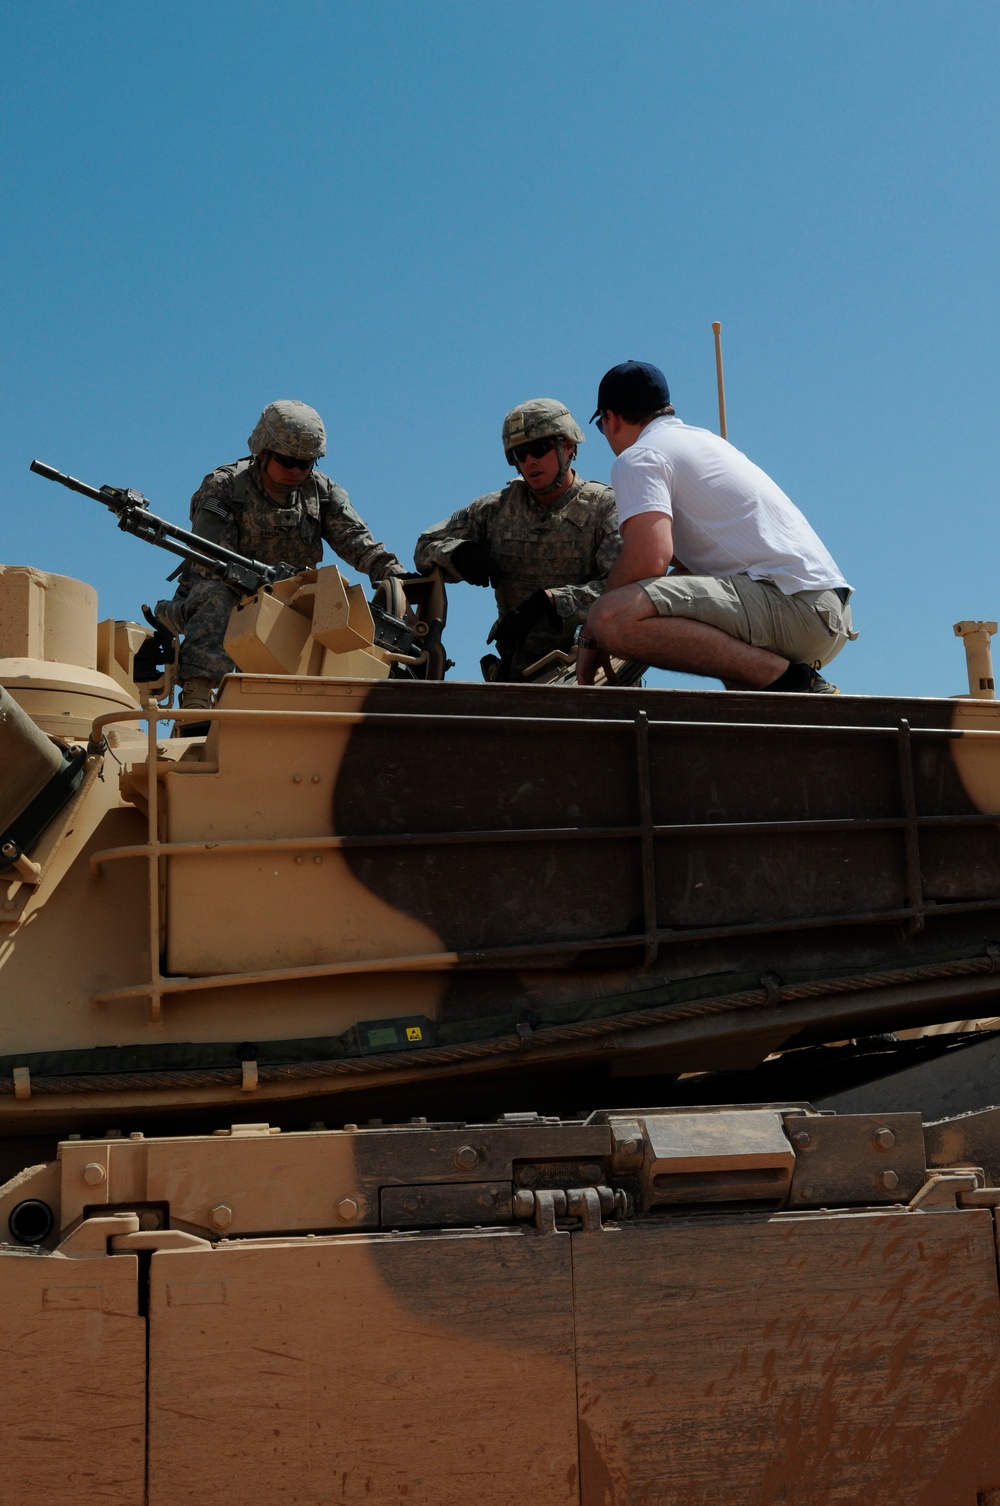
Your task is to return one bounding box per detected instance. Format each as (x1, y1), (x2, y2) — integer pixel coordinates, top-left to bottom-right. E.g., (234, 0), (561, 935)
(0, 675), (1000, 1133)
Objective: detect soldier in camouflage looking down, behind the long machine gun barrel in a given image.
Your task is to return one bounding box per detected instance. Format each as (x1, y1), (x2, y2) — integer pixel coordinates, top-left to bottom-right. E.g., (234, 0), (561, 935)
(155, 399), (407, 709)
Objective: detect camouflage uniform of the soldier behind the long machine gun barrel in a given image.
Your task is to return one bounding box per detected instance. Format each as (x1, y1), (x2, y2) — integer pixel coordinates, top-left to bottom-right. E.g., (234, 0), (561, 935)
(157, 458), (407, 682)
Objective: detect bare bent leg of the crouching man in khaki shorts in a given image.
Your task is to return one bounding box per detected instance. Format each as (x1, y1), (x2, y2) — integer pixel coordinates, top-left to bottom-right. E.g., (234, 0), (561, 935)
(589, 586), (788, 690)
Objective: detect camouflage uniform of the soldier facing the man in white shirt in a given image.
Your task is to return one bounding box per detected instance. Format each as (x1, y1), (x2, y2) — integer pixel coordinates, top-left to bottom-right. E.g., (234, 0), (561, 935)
(414, 476), (622, 673)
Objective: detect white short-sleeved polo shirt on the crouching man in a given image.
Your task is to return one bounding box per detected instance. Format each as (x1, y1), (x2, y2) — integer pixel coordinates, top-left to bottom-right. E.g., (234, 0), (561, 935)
(611, 417), (848, 596)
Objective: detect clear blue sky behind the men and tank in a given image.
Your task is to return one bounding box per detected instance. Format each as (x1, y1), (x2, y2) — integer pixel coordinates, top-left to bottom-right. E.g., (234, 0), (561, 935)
(0, 0), (1000, 694)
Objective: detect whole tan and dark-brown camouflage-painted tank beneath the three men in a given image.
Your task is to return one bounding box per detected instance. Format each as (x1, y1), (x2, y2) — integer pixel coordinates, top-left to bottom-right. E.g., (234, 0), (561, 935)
(0, 568), (1000, 1506)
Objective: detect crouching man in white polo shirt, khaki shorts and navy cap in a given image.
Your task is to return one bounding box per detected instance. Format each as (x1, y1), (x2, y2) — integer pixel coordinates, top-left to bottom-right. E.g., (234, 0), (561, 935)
(577, 361), (857, 694)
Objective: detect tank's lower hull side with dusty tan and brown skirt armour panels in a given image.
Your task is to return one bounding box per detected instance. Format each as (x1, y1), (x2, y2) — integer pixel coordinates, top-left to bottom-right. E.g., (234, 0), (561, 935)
(0, 1104), (1000, 1506)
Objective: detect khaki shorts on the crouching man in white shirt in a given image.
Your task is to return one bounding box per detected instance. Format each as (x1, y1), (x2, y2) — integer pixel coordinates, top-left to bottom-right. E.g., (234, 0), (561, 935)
(636, 575), (857, 664)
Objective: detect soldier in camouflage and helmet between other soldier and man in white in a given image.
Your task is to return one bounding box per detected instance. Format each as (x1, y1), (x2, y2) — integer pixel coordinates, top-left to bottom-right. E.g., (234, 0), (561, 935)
(414, 398), (622, 681)
